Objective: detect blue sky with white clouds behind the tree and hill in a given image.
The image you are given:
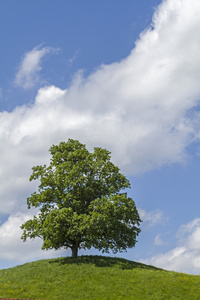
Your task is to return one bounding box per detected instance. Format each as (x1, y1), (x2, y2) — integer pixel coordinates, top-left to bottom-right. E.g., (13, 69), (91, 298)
(0, 0), (200, 274)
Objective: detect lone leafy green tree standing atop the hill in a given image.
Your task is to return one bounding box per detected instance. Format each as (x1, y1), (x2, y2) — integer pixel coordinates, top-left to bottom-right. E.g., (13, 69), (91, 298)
(21, 139), (141, 257)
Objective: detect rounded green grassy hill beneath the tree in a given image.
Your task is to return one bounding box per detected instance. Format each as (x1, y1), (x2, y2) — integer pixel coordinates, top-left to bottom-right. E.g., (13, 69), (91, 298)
(0, 256), (200, 300)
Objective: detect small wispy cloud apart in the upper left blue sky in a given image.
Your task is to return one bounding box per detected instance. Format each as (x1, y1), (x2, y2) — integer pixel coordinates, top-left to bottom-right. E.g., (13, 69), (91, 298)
(15, 46), (58, 89)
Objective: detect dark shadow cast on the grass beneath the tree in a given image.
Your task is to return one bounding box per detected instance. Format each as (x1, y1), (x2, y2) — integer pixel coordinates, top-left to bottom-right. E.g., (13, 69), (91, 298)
(50, 255), (162, 271)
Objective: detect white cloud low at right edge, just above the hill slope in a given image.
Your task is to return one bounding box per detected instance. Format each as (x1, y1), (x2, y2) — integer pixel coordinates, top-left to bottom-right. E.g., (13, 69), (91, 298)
(142, 218), (200, 274)
